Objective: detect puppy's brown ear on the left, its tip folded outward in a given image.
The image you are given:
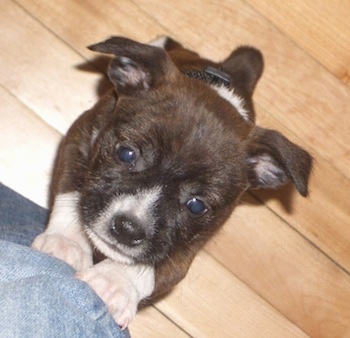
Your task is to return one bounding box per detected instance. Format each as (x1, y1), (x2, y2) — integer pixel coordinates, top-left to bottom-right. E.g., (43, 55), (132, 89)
(88, 36), (176, 95)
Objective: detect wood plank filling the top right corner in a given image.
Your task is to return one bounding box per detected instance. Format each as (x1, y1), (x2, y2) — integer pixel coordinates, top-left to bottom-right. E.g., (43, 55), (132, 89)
(246, 0), (350, 86)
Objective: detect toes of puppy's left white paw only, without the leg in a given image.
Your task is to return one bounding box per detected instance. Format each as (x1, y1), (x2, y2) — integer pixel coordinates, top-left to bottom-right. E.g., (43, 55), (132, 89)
(32, 232), (92, 270)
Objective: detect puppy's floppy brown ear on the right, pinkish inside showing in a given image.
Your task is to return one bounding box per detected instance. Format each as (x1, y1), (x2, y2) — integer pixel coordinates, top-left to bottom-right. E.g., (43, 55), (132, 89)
(246, 127), (312, 197)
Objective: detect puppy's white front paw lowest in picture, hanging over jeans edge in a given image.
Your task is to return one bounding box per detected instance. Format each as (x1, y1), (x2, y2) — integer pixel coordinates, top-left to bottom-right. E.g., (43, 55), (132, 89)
(76, 259), (154, 329)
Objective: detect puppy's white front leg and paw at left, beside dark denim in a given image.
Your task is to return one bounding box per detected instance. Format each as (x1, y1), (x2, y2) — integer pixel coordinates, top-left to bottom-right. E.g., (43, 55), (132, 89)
(32, 192), (92, 270)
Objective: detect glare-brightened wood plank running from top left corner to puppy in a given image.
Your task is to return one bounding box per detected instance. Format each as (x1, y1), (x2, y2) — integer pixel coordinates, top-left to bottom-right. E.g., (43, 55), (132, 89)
(0, 0), (101, 133)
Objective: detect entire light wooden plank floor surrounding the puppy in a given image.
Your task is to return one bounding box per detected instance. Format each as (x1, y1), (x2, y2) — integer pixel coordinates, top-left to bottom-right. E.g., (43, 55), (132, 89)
(0, 0), (350, 338)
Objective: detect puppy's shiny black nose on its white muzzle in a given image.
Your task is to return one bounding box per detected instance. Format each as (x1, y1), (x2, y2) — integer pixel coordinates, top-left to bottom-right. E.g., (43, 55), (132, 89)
(111, 215), (146, 246)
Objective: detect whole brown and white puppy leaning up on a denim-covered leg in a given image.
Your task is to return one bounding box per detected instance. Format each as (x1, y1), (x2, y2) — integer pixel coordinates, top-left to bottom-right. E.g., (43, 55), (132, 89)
(33, 37), (312, 328)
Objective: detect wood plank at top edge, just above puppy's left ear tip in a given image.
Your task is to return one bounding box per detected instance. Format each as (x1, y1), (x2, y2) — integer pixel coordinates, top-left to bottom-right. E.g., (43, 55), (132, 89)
(17, 0), (167, 58)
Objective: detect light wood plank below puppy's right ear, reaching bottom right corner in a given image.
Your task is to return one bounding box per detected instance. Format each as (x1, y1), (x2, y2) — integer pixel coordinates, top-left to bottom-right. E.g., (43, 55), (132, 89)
(207, 191), (350, 338)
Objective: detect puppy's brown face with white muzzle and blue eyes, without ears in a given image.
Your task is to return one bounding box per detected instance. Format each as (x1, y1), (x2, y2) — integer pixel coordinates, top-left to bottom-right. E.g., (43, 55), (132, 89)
(81, 78), (247, 263)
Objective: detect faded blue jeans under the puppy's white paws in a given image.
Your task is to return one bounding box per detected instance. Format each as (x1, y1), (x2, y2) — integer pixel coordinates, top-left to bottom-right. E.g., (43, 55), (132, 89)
(0, 184), (129, 338)
